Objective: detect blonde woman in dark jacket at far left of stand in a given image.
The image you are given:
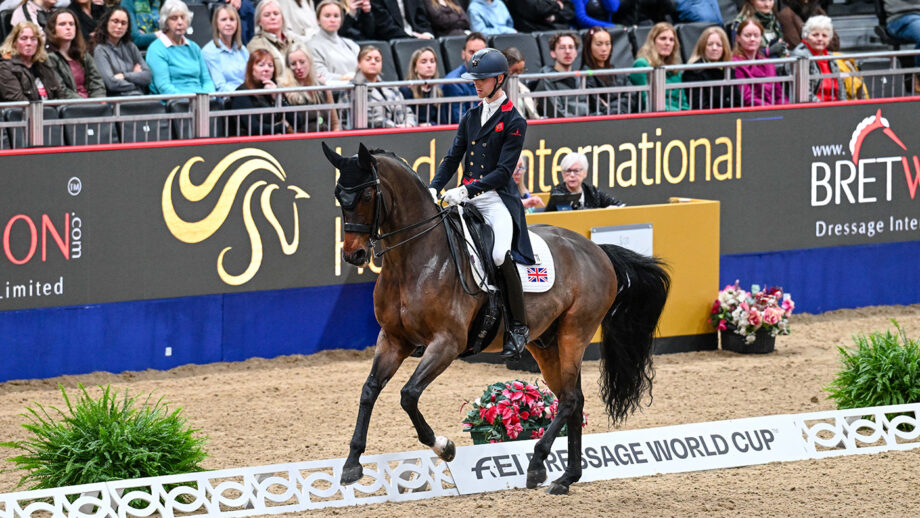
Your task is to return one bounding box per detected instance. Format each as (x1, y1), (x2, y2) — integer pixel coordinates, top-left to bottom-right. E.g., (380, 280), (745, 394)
(0, 22), (65, 102)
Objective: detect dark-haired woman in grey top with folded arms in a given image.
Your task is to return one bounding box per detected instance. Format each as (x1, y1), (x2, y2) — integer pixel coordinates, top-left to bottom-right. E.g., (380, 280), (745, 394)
(93, 6), (153, 96)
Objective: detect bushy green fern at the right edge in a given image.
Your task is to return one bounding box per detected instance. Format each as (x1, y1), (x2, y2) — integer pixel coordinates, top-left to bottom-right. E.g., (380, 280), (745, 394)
(825, 319), (920, 409)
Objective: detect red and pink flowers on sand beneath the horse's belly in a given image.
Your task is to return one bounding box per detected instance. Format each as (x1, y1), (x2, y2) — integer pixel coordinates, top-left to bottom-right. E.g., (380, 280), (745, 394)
(461, 380), (588, 443)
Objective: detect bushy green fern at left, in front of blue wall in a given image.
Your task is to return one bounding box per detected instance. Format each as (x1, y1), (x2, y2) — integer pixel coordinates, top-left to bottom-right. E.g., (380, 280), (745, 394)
(0, 385), (207, 489)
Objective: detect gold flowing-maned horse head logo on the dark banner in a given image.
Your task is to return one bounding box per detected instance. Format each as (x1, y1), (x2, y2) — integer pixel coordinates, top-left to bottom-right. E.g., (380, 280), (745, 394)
(162, 148), (310, 286)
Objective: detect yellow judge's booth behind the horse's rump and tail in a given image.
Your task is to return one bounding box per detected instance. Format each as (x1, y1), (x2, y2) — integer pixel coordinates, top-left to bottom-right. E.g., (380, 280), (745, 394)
(527, 198), (719, 341)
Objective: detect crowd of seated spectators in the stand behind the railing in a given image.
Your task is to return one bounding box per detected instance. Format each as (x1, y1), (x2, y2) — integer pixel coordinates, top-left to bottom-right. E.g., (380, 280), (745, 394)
(0, 0), (920, 134)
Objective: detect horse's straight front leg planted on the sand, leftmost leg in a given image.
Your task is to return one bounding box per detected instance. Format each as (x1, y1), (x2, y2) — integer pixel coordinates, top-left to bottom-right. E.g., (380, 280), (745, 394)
(341, 330), (408, 485)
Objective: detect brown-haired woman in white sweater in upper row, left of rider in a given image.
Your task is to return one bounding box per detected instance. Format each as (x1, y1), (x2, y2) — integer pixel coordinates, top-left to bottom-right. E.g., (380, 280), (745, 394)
(310, 0), (360, 84)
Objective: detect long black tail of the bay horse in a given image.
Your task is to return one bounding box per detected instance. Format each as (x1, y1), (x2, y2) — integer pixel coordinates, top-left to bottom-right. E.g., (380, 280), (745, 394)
(600, 245), (671, 424)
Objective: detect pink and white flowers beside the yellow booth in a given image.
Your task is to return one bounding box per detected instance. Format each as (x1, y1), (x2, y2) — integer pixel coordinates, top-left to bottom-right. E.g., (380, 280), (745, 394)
(709, 281), (795, 343)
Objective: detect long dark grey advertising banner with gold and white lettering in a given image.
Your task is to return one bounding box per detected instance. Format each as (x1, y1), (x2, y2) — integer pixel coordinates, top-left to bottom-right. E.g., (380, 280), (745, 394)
(0, 101), (920, 311)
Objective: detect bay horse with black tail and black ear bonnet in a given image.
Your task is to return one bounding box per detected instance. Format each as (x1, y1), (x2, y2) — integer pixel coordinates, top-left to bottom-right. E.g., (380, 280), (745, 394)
(322, 143), (670, 494)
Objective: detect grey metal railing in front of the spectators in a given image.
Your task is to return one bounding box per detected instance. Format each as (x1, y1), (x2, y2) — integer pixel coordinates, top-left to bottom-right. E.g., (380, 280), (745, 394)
(0, 50), (920, 149)
